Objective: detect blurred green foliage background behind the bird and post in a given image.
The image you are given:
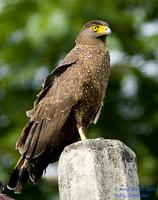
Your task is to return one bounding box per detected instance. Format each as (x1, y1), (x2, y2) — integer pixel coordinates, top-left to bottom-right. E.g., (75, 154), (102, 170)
(0, 0), (158, 200)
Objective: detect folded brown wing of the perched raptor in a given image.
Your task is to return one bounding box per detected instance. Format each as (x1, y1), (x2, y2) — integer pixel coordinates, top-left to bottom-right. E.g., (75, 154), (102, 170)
(16, 52), (78, 158)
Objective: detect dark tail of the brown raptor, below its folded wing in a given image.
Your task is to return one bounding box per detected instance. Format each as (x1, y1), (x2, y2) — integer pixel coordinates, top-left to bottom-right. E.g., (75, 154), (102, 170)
(7, 150), (51, 193)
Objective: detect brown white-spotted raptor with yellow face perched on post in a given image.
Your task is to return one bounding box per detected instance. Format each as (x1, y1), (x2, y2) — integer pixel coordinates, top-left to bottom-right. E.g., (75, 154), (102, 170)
(8, 20), (111, 193)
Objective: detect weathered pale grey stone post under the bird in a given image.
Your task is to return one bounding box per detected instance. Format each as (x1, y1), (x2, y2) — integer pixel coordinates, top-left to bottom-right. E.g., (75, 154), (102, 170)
(58, 138), (140, 200)
